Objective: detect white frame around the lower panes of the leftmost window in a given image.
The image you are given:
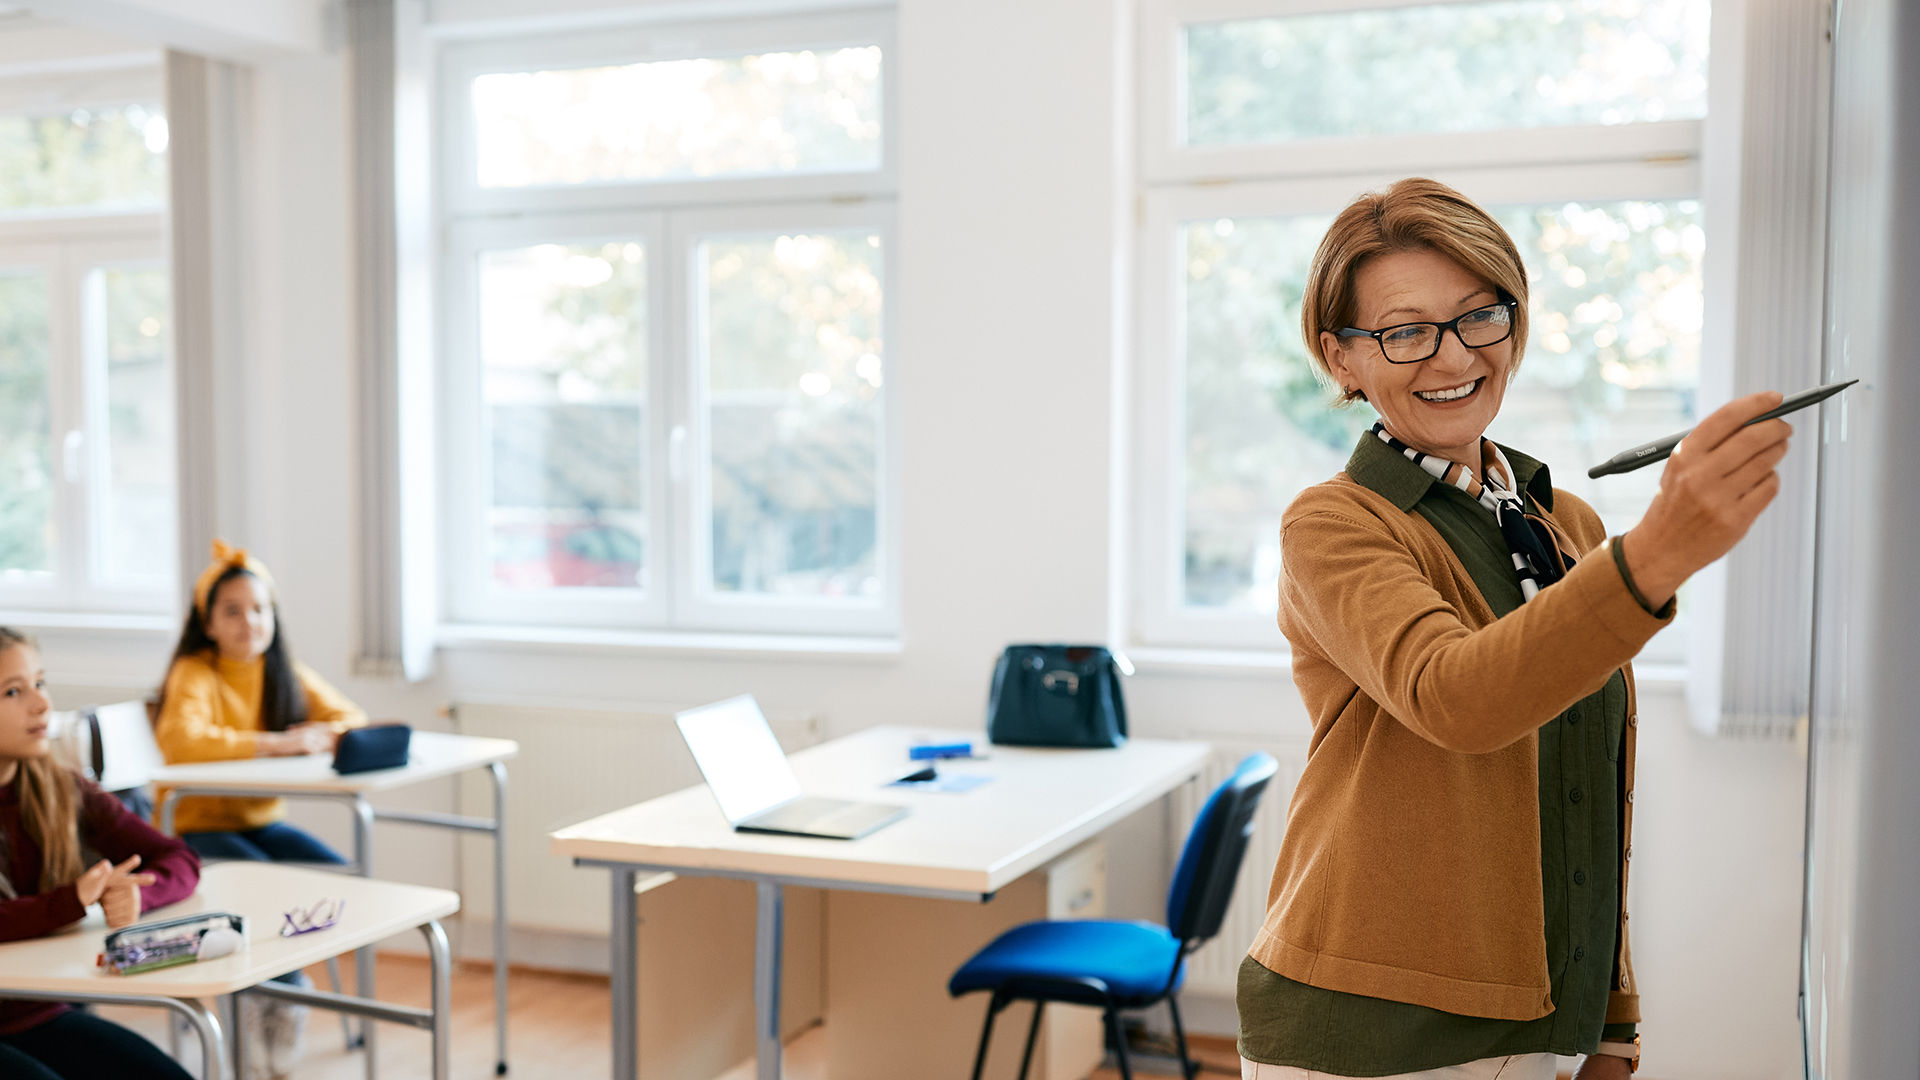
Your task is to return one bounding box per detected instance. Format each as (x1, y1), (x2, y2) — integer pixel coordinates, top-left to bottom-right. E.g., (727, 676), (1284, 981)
(0, 209), (179, 623)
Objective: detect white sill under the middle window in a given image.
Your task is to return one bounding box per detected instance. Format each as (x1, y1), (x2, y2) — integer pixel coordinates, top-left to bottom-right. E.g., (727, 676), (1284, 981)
(438, 623), (902, 663)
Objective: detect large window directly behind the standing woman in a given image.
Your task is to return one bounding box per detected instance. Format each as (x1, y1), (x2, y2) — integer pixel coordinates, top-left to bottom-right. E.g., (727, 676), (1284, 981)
(1135, 0), (1707, 659)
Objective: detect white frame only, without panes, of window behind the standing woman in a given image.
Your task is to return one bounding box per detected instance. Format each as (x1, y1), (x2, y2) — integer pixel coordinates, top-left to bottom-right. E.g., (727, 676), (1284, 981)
(1125, 0), (1716, 663)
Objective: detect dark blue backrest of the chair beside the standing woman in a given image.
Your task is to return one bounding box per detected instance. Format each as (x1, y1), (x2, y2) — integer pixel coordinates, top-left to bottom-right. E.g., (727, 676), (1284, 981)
(1167, 753), (1281, 947)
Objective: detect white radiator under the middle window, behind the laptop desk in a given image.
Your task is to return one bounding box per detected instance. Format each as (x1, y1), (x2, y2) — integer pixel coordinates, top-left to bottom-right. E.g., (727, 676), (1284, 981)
(451, 701), (820, 934)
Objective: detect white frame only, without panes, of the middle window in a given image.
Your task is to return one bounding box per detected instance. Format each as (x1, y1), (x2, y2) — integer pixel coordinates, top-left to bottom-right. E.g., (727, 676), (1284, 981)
(436, 12), (900, 638)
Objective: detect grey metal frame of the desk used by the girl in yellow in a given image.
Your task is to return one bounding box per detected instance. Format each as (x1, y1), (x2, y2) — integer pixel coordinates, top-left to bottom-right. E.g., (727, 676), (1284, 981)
(157, 761), (510, 1080)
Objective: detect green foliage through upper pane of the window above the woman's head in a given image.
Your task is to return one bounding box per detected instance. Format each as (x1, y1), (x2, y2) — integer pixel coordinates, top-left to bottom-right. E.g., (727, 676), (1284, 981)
(1187, 0), (1707, 144)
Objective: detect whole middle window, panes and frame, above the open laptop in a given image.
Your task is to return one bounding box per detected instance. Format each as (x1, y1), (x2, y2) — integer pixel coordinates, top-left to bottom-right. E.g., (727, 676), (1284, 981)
(440, 15), (899, 634)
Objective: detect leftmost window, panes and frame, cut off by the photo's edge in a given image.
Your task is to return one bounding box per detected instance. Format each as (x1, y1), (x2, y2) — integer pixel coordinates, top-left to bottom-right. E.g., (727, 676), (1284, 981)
(0, 87), (177, 619)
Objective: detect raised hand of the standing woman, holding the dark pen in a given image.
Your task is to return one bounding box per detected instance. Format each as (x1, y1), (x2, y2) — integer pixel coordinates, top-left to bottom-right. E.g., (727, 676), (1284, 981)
(1620, 390), (1793, 607)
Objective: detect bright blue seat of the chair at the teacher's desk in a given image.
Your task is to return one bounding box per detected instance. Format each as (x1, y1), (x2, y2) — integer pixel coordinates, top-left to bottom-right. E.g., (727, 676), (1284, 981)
(947, 919), (1185, 1005)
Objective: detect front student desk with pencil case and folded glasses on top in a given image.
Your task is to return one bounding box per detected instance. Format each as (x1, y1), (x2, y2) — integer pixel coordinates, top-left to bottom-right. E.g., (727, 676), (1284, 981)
(0, 863), (461, 1080)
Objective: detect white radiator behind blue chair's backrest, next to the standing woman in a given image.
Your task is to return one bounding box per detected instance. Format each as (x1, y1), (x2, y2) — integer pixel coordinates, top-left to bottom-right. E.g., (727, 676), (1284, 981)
(1167, 740), (1308, 999)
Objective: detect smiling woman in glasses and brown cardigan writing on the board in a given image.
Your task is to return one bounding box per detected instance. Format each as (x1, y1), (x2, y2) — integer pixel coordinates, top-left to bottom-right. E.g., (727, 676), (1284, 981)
(1238, 179), (1789, 1080)
